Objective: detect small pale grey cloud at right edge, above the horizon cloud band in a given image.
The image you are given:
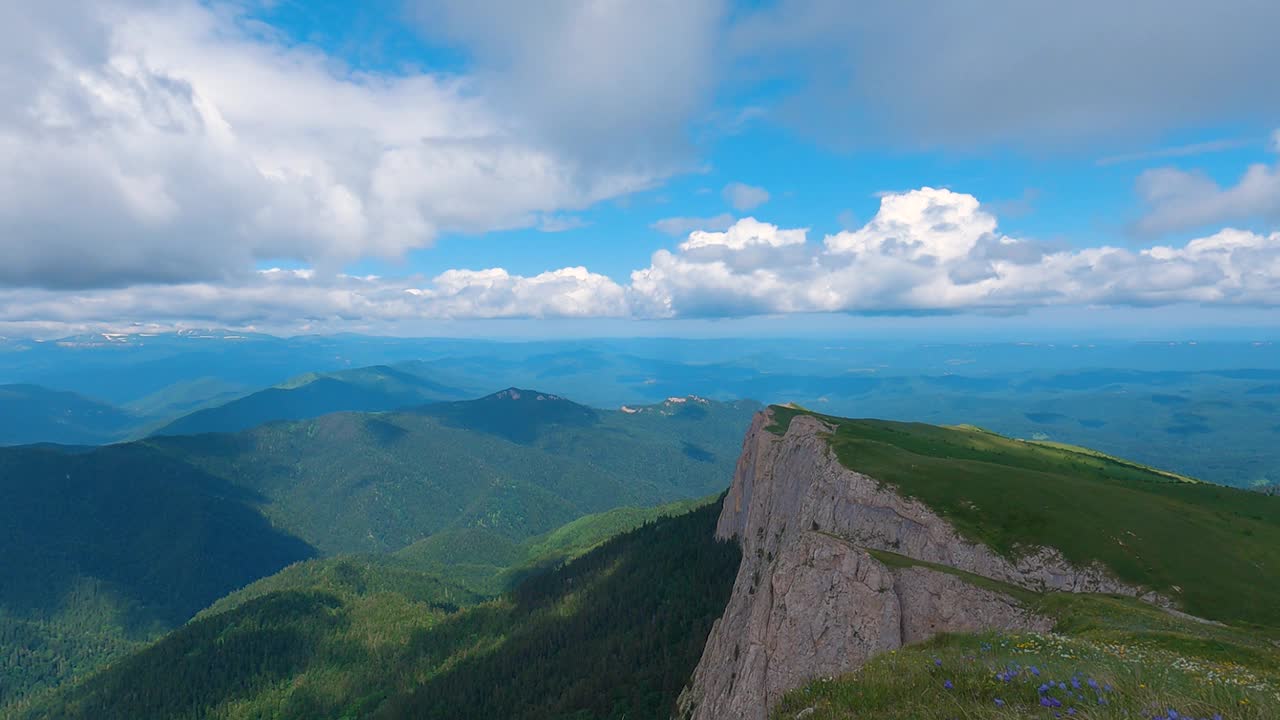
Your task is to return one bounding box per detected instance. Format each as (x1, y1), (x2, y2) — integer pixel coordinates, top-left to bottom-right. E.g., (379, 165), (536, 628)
(1137, 147), (1280, 234)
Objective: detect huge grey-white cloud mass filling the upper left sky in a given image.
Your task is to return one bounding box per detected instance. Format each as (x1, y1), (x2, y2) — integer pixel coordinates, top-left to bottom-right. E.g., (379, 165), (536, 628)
(0, 0), (671, 288)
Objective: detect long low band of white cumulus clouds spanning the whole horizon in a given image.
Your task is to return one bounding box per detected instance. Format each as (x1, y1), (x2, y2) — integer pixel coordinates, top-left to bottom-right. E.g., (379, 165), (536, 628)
(10, 187), (1280, 332)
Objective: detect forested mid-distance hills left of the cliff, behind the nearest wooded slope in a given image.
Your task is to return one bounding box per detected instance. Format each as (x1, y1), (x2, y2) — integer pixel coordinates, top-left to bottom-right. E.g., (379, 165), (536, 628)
(0, 393), (755, 707)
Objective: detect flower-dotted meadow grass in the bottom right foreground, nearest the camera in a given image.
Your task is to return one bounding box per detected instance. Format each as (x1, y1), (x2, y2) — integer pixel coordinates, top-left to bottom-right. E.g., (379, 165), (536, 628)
(773, 633), (1280, 720)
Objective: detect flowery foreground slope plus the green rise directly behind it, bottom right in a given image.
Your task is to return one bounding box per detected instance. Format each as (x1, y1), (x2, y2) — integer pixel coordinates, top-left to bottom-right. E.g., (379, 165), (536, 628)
(774, 594), (1280, 720)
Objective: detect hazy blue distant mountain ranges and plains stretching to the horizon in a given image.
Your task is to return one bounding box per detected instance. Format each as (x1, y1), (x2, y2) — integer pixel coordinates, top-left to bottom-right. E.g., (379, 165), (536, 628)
(0, 331), (1280, 487)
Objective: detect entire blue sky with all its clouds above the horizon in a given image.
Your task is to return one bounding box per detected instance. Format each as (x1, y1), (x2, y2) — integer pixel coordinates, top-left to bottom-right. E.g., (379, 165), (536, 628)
(0, 0), (1280, 337)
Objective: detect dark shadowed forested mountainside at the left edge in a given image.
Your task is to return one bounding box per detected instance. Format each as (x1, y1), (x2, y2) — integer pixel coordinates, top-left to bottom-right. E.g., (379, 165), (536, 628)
(0, 445), (315, 707)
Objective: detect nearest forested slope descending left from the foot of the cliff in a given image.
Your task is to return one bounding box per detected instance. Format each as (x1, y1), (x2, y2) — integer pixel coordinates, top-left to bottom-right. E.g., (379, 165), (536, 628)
(13, 503), (740, 720)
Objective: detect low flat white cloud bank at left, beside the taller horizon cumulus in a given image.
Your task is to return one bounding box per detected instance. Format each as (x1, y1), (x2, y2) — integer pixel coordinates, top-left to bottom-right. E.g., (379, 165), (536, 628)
(0, 268), (628, 332)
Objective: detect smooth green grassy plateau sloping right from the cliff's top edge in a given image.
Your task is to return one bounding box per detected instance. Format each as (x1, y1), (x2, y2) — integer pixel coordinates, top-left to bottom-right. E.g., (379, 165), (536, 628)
(769, 407), (1280, 626)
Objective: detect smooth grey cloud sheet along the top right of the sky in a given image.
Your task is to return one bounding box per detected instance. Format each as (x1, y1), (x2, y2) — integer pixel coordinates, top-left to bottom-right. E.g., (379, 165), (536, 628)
(731, 0), (1280, 147)
